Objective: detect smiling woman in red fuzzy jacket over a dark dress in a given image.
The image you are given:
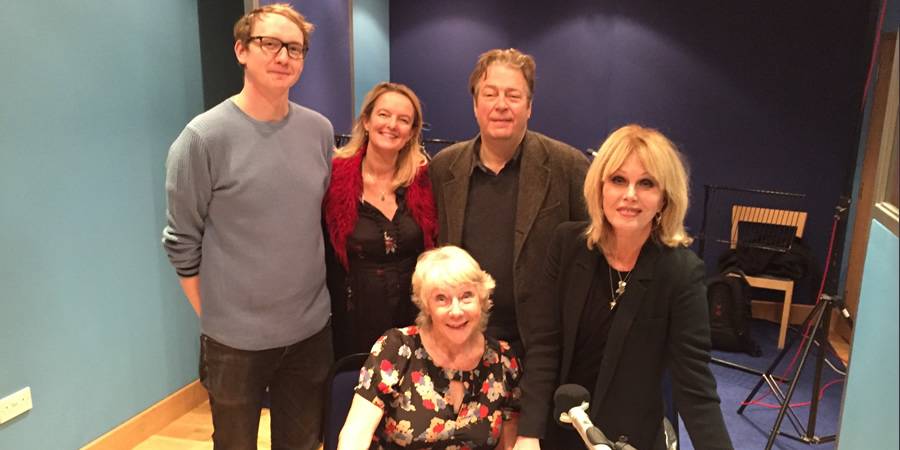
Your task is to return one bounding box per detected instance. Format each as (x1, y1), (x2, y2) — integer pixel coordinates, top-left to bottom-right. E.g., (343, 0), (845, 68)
(322, 83), (437, 358)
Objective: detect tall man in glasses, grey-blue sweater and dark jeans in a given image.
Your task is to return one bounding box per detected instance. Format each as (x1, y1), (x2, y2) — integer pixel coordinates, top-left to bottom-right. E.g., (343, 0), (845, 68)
(163, 5), (334, 449)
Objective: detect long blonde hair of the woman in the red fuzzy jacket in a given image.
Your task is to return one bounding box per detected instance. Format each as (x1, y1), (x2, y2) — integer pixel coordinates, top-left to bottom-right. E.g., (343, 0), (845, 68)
(334, 82), (428, 189)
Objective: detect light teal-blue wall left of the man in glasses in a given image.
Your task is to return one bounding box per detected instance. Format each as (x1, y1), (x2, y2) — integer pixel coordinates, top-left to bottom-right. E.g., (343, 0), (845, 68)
(0, 0), (203, 449)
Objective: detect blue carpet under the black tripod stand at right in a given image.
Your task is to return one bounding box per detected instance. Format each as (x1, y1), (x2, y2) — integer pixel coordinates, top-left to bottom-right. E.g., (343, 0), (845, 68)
(678, 320), (846, 450)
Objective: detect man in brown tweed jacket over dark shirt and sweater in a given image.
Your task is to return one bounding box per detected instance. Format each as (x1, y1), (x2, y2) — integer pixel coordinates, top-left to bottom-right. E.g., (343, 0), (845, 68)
(429, 49), (589, 362)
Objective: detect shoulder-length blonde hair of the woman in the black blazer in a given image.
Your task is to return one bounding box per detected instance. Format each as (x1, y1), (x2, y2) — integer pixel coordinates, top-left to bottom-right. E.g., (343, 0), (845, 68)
(584, 125), (693, 253)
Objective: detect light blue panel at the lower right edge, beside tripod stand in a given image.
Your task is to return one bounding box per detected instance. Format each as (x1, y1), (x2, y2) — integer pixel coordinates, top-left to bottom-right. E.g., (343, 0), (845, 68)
(838, 222), (900, 449)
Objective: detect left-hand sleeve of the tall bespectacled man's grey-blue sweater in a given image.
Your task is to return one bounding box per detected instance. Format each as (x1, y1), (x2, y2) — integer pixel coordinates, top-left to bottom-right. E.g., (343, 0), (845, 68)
(162, 126), (212, 277)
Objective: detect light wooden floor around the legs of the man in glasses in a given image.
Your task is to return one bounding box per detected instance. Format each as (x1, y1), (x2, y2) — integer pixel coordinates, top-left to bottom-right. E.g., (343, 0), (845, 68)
(135, 401), (272, 450)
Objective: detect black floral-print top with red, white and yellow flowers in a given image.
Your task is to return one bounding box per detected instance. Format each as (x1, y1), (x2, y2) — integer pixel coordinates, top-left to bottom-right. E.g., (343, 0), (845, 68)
(356, 327), (521, 450)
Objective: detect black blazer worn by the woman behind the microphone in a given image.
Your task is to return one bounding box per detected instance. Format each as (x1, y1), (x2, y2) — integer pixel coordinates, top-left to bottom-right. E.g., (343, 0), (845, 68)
(519, 222), (733, 450)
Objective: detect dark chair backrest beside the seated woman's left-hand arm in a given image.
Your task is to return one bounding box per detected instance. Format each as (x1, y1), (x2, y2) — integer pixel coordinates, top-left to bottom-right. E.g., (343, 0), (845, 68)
(322, 353), (369, 450)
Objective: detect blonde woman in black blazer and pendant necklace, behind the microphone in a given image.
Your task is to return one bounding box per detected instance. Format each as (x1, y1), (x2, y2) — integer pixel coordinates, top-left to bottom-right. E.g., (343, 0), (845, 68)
(516, 125), (733, 450)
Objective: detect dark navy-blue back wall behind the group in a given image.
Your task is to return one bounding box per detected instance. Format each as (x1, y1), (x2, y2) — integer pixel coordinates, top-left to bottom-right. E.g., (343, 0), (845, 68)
(391, 0), (871, 302)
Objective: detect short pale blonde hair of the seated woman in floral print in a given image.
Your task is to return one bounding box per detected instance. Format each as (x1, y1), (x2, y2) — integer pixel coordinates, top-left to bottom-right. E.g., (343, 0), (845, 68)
(412, 245), (496, 332)
